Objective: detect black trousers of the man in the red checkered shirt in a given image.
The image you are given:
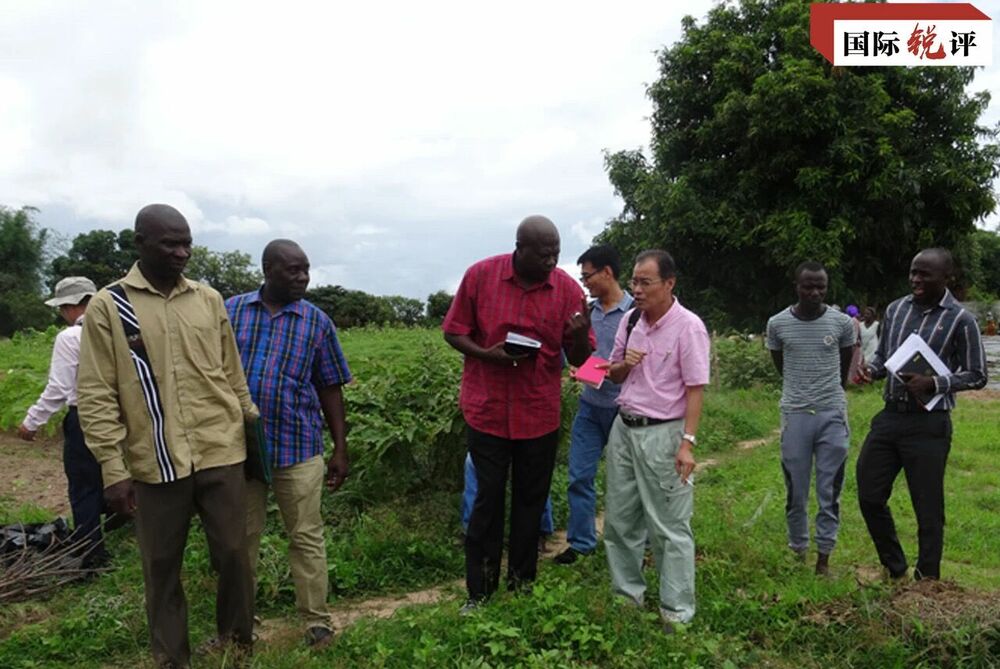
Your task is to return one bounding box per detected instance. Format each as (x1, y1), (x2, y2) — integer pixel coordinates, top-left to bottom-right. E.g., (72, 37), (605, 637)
(465, 427), (559, 600)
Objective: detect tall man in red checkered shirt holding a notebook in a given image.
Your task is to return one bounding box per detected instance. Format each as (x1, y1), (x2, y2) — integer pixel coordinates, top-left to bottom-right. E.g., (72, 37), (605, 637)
(442, 216), (596, 612)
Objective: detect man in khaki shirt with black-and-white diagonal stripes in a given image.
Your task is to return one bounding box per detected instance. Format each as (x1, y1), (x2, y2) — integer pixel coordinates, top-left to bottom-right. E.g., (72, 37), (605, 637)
(78, 204), (257, 667)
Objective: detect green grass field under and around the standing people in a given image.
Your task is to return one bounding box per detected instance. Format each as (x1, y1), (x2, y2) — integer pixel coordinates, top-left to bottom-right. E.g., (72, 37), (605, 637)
(0, 330), (1000, 669)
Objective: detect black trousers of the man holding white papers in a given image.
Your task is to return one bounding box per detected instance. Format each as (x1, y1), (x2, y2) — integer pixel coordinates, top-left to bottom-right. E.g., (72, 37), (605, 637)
(856, 411), (951, 578)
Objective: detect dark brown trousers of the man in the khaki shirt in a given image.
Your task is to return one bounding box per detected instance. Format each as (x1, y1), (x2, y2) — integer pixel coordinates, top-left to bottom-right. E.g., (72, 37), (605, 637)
(135, 463), (253, 667)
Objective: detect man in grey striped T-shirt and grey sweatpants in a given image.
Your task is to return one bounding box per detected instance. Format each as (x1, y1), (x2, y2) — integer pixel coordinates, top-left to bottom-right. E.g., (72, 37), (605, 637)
(767, 262), (856, 574)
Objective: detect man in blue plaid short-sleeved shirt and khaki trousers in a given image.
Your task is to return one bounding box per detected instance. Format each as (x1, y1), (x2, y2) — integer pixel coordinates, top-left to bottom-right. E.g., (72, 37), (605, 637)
(226, 239), (351, 646)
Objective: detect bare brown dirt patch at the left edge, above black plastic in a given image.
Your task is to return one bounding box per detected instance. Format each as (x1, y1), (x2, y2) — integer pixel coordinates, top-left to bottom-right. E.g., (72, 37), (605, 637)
(0, 432), (70, 516)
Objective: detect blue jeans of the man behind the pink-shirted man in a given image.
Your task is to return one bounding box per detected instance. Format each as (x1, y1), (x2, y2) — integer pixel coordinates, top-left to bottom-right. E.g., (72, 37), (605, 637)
(566, 400), (618, 553)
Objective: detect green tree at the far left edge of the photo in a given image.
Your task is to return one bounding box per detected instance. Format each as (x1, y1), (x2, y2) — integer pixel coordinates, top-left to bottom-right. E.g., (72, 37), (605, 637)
(0, 206), (53, 337)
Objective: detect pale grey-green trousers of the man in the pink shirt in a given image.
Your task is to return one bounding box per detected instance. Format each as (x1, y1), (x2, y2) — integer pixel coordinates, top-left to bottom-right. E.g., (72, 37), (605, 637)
(604, 416), (695, 623)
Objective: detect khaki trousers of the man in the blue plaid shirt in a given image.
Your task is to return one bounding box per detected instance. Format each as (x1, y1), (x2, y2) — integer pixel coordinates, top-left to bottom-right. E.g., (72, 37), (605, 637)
(247, 455), (330, 629)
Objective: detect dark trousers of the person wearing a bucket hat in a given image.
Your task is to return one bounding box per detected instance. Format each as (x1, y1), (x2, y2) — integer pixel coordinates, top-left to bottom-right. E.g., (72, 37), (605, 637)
(63, 406), (106, 563)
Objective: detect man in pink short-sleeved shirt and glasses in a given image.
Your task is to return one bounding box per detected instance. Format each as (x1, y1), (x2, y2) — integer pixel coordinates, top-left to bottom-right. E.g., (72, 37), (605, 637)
(604, 250), (710, 633)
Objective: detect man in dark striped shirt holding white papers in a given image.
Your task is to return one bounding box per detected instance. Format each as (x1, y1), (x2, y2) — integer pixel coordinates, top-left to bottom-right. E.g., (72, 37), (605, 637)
(857, 248), (986, 579)
